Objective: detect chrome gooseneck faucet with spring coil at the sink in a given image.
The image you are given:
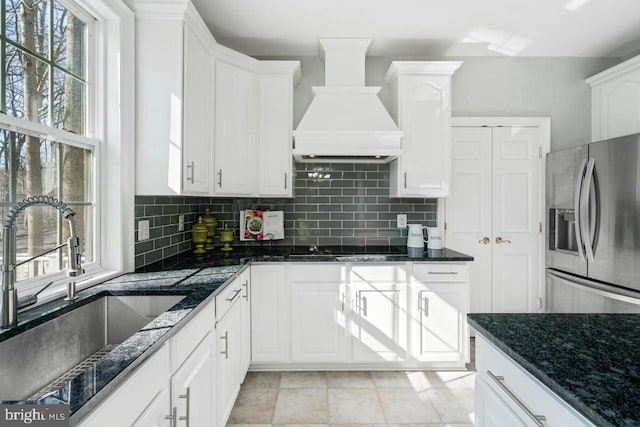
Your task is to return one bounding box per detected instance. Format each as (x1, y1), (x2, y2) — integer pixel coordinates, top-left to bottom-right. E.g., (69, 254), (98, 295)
(0, 196), (84, 328)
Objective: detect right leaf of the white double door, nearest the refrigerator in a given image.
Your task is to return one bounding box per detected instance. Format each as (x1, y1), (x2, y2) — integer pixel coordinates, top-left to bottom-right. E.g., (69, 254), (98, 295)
(492, 126), (542, 312)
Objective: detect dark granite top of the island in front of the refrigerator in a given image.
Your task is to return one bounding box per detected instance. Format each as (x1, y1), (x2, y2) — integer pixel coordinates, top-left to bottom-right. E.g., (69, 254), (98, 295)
(468, 313), (640, 426)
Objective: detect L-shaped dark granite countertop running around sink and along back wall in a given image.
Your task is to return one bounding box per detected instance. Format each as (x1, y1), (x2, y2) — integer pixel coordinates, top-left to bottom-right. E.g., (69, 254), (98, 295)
(0, 245), (473, 424)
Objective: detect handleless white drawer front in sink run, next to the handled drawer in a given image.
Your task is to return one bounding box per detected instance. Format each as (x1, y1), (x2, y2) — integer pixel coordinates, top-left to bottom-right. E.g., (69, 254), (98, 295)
(171, 302), (216, 372)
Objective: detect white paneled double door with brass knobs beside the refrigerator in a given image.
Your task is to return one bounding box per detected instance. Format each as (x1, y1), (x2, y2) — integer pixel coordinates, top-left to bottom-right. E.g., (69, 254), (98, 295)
(446, 122), (546, 312)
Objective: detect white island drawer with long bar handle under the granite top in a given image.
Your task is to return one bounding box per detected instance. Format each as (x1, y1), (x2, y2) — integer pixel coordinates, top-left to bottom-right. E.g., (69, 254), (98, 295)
(476, 336), (593, 427)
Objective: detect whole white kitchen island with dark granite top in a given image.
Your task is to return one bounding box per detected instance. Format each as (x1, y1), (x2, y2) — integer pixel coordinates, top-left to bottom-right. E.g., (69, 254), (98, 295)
(468, 313), (640, 426)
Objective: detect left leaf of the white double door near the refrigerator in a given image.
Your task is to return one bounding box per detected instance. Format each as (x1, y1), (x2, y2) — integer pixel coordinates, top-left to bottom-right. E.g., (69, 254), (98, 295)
(446, 127), (492, 313)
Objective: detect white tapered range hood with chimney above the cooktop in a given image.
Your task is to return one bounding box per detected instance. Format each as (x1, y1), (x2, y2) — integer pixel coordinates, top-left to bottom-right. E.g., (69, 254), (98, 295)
(293, 39), (402, 163)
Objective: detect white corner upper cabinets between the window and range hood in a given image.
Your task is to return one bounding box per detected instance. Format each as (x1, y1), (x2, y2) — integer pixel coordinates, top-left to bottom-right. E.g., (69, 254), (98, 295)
(133, 0), (300, 197)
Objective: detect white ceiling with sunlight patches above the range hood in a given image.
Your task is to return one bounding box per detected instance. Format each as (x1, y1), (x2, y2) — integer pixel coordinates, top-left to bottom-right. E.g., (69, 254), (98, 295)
(193, 0), (640, 57)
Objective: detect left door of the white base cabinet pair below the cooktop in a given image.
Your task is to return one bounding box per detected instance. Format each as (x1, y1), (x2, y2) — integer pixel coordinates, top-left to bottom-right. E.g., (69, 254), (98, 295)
(289, 282), (347, 362)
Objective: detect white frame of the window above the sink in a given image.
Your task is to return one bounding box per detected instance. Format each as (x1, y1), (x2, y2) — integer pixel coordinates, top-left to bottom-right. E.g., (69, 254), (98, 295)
(0, 0), (135, 303)
